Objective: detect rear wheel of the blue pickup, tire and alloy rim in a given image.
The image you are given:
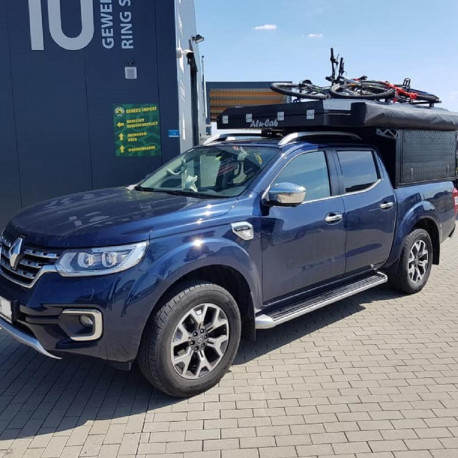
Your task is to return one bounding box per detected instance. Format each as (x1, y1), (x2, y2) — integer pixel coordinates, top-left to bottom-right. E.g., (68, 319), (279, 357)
(388, 229), (433, 294)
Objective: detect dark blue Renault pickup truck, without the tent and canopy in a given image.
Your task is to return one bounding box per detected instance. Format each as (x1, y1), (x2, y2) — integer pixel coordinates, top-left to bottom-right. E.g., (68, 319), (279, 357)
(0, 101), (458, 397)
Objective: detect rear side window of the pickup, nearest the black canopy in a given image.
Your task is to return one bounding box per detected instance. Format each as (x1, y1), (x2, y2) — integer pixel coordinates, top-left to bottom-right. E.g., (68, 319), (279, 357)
(337, 151), (379, 193)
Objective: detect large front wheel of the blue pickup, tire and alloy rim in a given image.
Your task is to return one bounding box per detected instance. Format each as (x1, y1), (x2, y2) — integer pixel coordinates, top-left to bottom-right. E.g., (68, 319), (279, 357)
(137, 282), (242, 398)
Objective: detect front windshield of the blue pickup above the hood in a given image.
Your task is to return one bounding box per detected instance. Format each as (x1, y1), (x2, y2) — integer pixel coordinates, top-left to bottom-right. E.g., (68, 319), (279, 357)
(138, 145), (278, 197)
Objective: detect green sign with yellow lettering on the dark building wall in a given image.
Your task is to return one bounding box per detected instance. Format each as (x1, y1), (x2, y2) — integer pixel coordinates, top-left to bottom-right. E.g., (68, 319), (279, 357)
(113, 104), (161, 157)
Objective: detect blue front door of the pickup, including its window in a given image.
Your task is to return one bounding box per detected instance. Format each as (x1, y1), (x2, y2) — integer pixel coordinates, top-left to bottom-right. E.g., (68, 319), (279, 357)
(262, 151), (345, 303)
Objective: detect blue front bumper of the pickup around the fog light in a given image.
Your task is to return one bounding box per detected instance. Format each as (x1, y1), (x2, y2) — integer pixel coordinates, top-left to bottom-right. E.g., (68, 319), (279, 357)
(0, 264), (157, 363)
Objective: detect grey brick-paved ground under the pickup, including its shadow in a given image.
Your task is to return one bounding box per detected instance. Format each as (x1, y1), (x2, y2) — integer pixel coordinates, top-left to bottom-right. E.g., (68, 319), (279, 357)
(0, 233), (458, 458)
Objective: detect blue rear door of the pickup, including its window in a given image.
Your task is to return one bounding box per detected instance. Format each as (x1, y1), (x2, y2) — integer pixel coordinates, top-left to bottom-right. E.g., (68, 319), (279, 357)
(336, 149), (396, 274)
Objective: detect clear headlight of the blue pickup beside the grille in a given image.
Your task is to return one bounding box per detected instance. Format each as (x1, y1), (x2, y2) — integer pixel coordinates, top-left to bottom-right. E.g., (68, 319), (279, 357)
(56, 242), (148, 277)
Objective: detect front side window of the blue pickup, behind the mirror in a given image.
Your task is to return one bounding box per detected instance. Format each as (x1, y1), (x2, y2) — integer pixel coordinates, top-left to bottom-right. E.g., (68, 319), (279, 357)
(275, 151), (331, 201)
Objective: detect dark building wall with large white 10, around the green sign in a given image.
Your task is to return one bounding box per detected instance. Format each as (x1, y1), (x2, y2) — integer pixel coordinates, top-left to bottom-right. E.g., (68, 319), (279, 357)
(0, 0), (186, 231)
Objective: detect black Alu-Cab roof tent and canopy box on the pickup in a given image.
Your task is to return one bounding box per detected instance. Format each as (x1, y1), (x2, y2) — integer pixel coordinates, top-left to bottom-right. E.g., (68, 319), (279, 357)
(218, 99), (458, 186)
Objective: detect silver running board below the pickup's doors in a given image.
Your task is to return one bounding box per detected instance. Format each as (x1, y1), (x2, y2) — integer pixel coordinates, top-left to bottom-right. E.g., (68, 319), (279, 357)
(255, 272), (388, 329)
